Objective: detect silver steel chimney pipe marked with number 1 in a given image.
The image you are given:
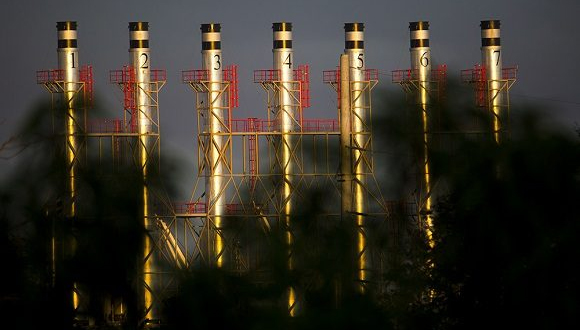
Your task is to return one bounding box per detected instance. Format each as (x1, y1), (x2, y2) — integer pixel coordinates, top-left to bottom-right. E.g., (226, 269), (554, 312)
(56, 21), (85, 310)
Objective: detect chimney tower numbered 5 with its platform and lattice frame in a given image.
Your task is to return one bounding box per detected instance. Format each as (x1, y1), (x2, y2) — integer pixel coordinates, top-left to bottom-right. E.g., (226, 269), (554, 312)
(323, 23), (380, 292)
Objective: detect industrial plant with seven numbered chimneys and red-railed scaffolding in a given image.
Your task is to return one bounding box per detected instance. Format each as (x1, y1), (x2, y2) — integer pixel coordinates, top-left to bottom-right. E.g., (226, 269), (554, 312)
(37, 21), (516, 323)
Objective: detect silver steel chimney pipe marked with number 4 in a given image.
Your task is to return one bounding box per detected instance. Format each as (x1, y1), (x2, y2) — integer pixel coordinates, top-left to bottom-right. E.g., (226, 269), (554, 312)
(272, 22), (299, 316)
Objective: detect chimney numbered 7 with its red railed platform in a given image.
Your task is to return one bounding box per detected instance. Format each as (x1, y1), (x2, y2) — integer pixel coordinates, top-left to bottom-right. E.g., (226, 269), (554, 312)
(461, 20), (518, 144)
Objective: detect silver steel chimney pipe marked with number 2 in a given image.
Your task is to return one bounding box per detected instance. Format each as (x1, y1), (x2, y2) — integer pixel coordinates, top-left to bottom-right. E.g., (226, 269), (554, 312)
(129, 22), (159, 320)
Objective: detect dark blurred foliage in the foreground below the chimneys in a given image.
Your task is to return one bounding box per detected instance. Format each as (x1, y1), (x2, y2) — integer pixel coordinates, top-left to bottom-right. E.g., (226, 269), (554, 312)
(0, 82), (580, 329)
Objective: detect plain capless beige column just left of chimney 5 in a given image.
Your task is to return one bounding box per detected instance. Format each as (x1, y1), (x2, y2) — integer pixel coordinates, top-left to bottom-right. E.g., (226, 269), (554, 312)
(338, 54), (352, 220)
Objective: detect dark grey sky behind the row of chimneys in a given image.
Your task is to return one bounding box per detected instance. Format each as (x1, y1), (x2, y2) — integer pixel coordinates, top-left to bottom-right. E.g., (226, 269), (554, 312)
(0, 0), (580, 196)
